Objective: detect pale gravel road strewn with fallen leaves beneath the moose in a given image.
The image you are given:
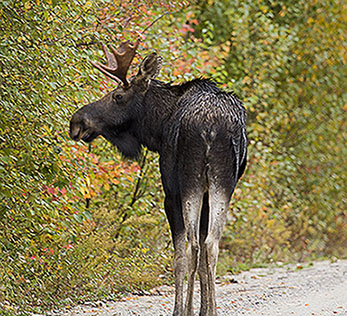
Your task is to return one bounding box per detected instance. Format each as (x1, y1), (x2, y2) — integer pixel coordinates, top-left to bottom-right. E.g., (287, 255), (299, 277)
(59, 260), (347, 316)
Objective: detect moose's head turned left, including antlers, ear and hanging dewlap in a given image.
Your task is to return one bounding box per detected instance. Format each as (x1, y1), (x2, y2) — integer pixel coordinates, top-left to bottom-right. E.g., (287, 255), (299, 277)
(70, 41), (162, 157)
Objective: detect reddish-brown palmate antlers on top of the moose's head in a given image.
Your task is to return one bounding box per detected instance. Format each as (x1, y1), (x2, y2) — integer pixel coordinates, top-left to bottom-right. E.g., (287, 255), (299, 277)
(91, 40), (139, 86)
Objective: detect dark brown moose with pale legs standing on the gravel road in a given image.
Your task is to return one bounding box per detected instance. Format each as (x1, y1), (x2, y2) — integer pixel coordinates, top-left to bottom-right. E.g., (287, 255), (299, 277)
(70, 41), (248, 316)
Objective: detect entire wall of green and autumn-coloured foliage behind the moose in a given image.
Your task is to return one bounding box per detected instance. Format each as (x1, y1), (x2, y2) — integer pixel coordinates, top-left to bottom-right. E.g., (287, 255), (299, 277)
(0, 0), (347, 314)
